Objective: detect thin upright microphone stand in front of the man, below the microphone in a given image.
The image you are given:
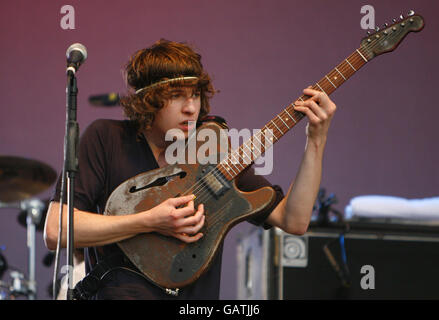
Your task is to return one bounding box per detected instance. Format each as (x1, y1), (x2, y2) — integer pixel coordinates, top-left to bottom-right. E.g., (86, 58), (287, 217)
(61, 69), (79, 300)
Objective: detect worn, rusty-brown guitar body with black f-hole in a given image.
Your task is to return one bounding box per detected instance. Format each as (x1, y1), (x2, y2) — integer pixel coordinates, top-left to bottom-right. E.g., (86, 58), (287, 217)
(104, 122), (275, 289)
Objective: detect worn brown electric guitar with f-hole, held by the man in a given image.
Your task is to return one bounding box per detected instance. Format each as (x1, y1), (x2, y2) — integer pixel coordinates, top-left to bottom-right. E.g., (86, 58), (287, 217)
(104, 11), (424, 289)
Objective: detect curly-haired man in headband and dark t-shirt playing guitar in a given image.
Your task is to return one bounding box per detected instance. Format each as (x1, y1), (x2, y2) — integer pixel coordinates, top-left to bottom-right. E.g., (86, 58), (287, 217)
(44, 40), (336, 299)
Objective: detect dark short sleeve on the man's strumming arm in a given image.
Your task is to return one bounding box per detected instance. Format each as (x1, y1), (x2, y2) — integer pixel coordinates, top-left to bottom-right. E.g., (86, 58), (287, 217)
(51, 120), (108, 212)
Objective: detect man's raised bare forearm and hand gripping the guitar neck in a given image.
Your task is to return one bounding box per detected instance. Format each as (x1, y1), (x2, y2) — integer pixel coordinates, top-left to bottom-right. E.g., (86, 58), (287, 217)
(267, 88), (336, 235)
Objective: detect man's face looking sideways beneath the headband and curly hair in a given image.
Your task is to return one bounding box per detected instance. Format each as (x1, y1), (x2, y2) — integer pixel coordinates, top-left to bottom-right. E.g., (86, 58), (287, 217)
(152, 87), (201, 137)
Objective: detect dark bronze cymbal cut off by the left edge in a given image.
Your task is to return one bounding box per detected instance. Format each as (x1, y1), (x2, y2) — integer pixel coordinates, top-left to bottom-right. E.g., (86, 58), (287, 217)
(0, 156), (57, 202)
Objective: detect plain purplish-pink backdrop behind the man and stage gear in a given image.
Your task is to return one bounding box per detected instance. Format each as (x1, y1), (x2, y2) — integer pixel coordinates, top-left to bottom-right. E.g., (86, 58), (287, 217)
(0, 0), (439, 299)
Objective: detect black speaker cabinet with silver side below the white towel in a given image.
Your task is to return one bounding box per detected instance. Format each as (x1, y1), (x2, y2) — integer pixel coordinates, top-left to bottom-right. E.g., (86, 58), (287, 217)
(237, 224), (439, 300)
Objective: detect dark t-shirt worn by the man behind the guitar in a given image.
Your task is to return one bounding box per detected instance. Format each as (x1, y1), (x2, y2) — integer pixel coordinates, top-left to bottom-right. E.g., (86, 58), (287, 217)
(52, 119), (283, 299)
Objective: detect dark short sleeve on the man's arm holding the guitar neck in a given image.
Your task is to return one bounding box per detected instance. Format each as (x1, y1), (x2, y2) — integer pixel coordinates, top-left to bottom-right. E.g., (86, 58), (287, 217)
(237, 167), (284, 229)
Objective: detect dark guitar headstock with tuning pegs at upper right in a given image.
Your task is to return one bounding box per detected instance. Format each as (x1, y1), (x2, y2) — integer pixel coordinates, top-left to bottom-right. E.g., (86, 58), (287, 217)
(361, 11), (424, 60)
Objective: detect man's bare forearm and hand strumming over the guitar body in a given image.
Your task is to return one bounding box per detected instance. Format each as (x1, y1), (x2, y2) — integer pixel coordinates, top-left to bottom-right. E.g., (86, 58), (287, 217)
(44, 195), (204, 250)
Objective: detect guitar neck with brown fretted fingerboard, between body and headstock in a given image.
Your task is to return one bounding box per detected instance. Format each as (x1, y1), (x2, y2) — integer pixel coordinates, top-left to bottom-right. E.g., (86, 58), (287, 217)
(217, 48), (369, 180)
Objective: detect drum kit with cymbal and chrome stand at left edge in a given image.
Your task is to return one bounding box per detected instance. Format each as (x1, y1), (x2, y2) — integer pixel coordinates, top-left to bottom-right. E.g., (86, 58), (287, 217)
(0, 156), (57, 300)
